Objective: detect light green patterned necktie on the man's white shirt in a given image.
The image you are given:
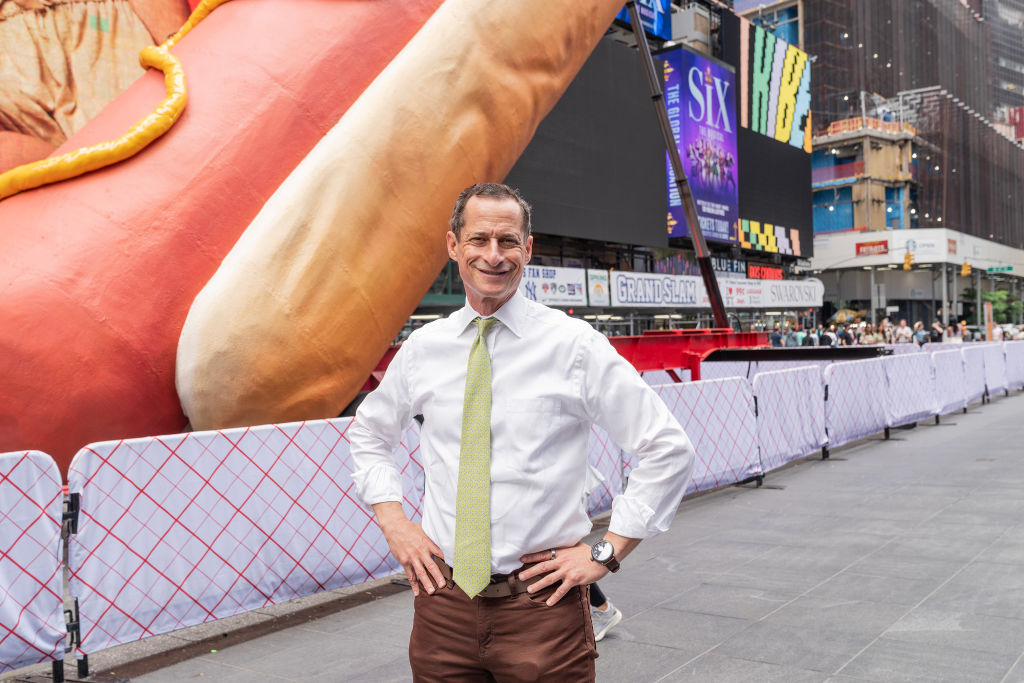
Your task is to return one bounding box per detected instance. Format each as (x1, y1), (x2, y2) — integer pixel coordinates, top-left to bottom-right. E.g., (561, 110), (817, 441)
(453, 317), (495, 598)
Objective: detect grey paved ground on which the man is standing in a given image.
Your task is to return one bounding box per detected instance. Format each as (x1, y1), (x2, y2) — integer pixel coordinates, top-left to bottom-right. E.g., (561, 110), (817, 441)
(9, 391), (1024, 683)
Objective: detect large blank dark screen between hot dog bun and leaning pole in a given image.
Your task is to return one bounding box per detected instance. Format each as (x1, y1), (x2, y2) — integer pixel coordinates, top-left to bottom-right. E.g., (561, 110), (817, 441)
(505, 39), (669, 247)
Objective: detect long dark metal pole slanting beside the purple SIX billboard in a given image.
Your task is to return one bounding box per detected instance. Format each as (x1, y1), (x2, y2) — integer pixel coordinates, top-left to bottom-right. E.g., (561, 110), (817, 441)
(626, 0), (729, 328)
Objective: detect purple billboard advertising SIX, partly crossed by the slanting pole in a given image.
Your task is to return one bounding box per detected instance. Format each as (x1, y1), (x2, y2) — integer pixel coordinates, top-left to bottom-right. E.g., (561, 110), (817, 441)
(662, 48), (739, 243)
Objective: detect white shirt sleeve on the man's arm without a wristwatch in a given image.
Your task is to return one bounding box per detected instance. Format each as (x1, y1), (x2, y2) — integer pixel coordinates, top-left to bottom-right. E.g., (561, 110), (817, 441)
(348, 342), (413, 507)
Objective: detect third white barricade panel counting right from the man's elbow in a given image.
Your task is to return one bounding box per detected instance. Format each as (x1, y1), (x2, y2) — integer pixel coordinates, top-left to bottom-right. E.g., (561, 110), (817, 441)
(822, 358), (886, 449)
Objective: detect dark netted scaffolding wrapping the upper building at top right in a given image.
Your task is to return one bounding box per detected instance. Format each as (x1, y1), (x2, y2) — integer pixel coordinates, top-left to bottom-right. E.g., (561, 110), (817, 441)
(803, 0), (1024, 247)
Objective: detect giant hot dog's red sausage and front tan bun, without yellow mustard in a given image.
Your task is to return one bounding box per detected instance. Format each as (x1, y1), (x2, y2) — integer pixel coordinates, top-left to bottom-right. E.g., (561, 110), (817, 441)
(0, 0), (622, 469)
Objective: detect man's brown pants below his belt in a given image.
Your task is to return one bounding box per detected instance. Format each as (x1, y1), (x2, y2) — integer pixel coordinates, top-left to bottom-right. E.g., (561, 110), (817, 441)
(409, 582), (597, 683)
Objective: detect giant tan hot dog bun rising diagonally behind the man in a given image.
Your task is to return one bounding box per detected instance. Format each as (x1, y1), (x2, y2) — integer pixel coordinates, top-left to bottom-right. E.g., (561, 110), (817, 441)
(176, 0), (622, 429)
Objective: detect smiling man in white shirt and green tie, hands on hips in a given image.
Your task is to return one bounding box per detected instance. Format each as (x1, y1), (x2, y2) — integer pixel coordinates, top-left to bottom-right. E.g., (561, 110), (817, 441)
(348, 183), (694, 681)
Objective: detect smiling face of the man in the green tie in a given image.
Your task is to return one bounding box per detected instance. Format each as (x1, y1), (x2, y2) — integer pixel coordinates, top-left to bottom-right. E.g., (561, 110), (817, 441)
(446, 197), (534, 315)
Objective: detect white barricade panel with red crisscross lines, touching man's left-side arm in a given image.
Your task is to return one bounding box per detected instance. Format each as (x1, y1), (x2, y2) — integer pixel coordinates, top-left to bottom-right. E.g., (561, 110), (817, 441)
(69, 418), (423, 653)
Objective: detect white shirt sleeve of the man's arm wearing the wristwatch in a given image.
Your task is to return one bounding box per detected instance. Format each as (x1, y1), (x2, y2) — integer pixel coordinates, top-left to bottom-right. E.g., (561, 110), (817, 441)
(581, 335), (695, 539)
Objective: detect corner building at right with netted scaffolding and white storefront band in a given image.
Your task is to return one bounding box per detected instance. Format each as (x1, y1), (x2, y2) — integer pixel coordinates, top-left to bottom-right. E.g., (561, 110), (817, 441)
(736, 0), (1024, 322)
